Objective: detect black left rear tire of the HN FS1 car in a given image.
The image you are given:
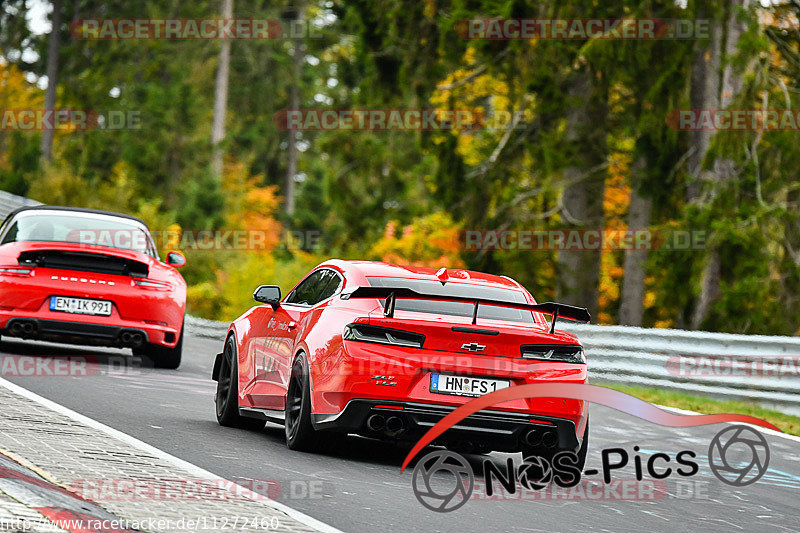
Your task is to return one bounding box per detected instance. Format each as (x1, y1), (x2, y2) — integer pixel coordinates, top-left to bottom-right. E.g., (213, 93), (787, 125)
(284, 355), (319, 451)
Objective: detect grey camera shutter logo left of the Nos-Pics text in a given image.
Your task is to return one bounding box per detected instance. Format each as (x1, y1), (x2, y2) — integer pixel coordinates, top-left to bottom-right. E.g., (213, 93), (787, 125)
(411, 450), (475, 513)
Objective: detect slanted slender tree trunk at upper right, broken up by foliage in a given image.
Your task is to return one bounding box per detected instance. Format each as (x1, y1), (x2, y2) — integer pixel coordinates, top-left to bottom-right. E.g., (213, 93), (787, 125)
(691, 0), (749, 329)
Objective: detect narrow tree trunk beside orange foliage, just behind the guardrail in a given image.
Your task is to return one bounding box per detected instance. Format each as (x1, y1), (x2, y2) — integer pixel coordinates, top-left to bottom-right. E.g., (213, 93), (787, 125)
(619, 156), (653, 327)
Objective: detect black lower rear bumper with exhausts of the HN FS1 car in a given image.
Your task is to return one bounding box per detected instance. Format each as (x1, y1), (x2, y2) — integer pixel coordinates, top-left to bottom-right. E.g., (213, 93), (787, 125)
(312, 399), (582, 452)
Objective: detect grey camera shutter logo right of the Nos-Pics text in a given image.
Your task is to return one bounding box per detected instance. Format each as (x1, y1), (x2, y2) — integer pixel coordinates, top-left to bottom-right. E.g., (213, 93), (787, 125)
(708, 425), (769, 487)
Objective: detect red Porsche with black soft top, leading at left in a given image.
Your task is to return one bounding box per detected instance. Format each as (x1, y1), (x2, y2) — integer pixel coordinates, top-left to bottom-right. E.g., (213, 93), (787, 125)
(0, 206), (186, 368)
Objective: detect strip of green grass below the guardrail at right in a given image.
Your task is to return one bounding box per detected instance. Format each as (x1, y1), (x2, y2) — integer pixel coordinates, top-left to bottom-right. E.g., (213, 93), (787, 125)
(603, 384), (800, 436)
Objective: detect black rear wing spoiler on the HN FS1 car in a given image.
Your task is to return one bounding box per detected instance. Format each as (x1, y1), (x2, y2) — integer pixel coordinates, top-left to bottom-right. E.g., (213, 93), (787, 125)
(341, 287), (592, 333)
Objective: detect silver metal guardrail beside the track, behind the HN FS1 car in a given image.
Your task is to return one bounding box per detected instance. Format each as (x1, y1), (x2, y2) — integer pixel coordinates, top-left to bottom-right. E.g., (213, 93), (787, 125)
(186, 316), (800, 416)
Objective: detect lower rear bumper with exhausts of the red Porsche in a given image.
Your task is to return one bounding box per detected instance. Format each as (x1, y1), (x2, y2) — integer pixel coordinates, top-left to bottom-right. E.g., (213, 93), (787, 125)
(0, 312), (180, 348)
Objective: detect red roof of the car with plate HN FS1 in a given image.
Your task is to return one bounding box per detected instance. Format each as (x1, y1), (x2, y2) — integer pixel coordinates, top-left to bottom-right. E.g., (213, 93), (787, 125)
(319, 259), (525, 291)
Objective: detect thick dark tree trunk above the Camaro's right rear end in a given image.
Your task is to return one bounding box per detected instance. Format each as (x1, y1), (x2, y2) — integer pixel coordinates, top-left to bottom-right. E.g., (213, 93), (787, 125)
(556, 68), (608, 316)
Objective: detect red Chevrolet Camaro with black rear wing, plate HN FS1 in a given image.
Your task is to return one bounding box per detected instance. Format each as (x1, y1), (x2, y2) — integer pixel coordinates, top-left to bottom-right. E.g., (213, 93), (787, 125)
(213, 260), (589, 461)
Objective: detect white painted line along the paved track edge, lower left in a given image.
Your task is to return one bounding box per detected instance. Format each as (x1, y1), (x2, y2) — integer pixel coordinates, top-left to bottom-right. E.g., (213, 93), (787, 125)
(0, 378), (342, 533)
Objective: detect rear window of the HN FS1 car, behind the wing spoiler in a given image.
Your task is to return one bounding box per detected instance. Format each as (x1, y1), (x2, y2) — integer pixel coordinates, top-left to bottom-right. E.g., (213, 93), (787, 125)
(367, 276), (535, 323)
